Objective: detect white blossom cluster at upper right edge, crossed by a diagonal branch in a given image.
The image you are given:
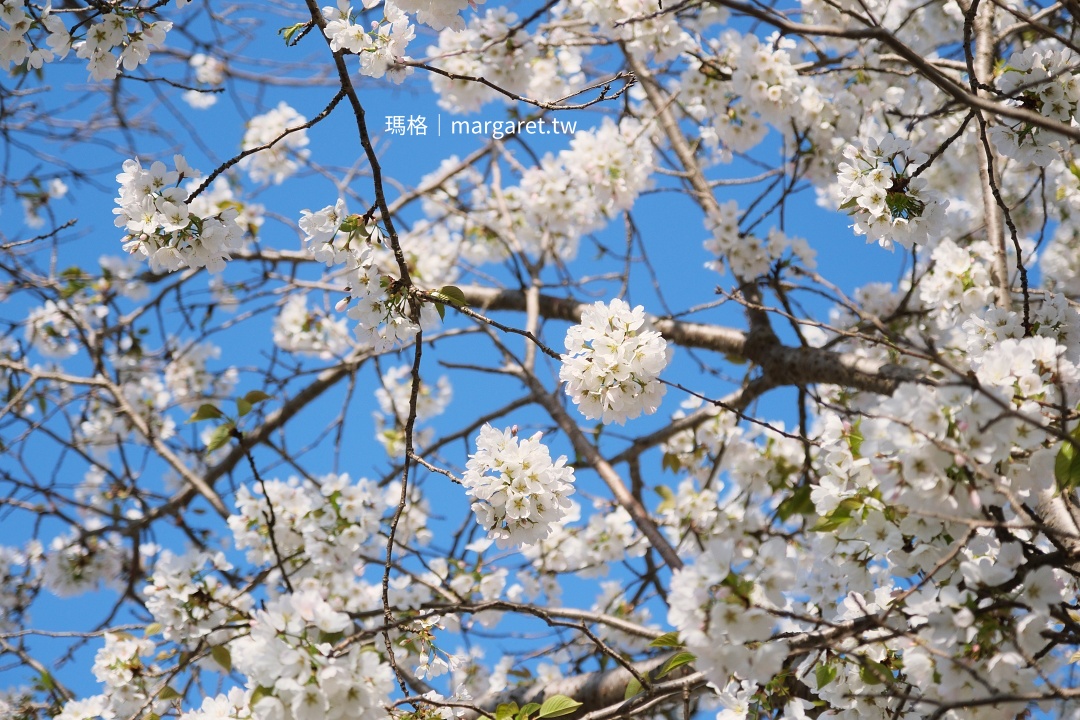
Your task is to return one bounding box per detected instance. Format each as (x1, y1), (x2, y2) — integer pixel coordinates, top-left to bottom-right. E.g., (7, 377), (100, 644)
(989, 45), (1080, 167)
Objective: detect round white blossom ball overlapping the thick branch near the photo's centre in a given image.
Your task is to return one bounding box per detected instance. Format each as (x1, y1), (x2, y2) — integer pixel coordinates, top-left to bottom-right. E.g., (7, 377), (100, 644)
(558, 298), (670, 425)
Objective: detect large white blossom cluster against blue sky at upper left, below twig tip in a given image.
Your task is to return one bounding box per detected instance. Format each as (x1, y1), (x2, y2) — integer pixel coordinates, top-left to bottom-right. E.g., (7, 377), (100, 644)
(112, 154), (244, 272)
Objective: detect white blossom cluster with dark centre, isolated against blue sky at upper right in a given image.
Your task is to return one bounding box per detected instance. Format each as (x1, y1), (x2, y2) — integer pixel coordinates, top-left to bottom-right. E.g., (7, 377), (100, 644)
(837, 133), (947, 249)
